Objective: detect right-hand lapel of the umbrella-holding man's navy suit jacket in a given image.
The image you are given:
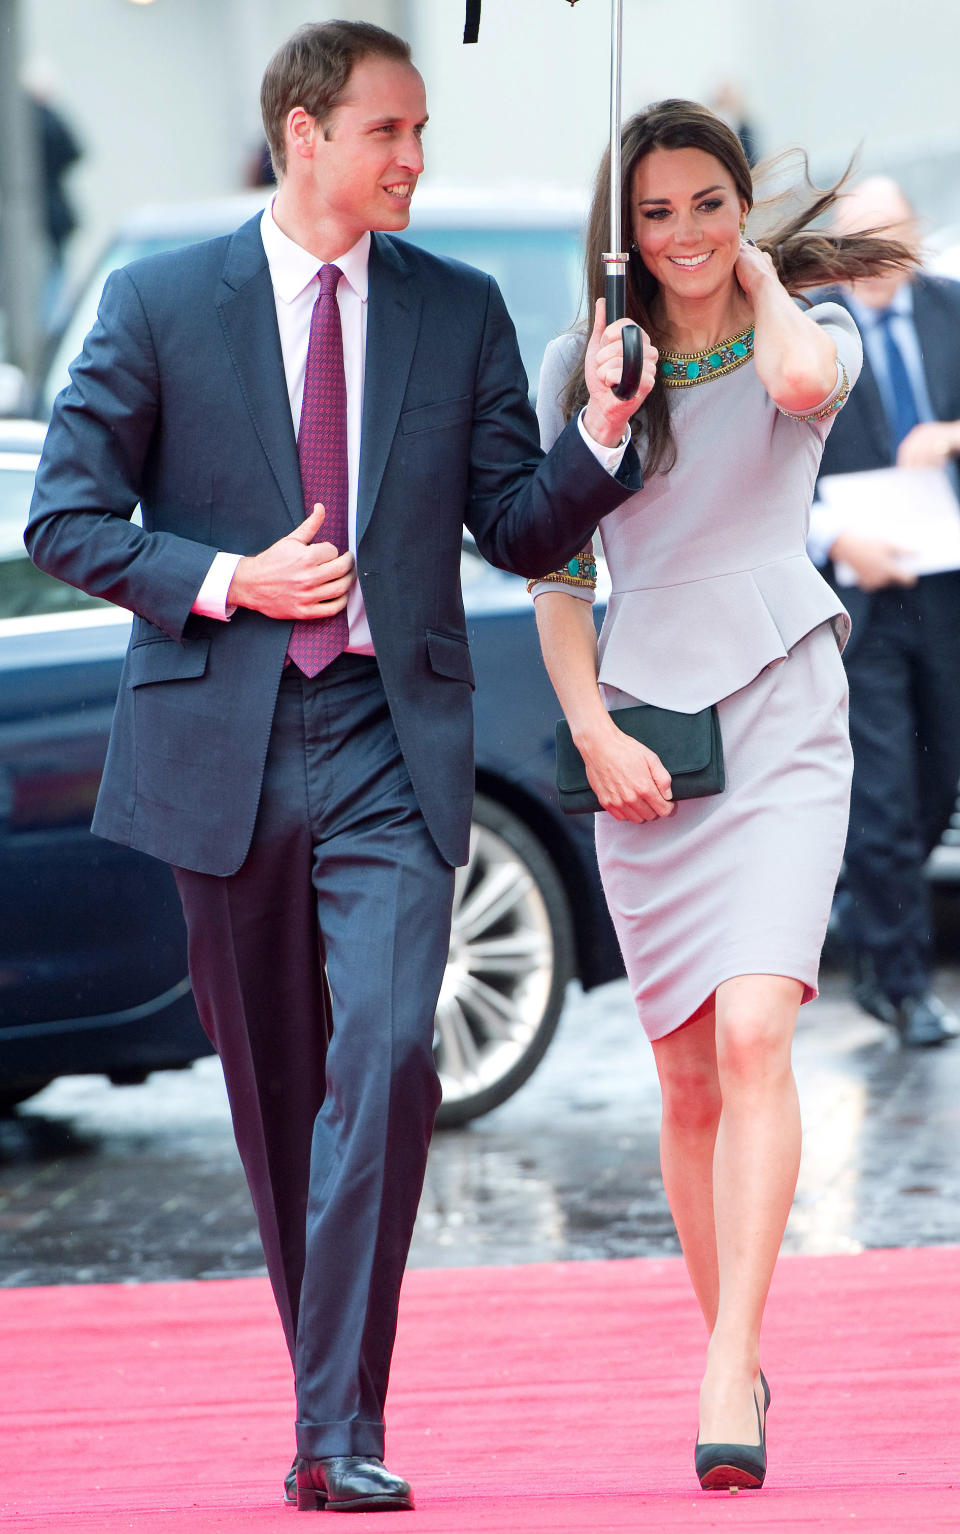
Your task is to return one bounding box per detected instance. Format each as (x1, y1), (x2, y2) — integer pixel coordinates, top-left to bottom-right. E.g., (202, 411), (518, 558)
(357, 233), (422, 545)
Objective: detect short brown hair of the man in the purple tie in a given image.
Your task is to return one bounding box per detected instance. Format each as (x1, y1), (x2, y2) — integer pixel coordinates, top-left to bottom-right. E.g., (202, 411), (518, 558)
(261, 21), (411, 181)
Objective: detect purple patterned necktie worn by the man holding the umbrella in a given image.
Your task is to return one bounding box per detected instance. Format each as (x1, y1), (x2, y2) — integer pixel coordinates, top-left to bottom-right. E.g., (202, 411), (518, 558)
(287, 265), (348, 676)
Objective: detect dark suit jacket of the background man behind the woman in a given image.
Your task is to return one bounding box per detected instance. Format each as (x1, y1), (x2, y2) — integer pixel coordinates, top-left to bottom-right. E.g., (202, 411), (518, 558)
(820, 276), (960, 658)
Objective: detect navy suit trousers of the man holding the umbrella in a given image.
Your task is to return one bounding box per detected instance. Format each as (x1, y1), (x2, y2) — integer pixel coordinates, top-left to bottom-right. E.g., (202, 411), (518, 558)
(175, 655), (454, 1457)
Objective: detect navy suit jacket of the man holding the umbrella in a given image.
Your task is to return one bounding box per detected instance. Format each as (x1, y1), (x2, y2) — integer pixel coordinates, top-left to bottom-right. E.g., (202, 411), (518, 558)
(26, 215), (638, 874)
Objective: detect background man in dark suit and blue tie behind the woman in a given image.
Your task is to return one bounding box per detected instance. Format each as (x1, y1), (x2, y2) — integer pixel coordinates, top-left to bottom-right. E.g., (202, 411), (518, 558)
(808, 176), (960, 1046)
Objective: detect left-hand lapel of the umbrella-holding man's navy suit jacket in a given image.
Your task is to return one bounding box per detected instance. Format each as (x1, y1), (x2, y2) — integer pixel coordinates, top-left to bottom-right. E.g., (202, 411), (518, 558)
(218, 213), (304, 526)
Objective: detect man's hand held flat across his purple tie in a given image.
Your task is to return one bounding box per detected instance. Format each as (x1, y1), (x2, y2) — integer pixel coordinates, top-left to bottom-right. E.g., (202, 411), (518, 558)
(227, 502), (357, 618)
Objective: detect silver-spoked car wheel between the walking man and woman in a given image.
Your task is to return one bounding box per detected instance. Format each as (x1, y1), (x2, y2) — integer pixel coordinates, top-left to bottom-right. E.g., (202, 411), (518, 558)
(434, 795), (574, 1129)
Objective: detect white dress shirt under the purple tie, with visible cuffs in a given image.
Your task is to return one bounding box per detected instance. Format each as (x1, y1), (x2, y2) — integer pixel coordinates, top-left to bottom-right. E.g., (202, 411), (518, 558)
(193, 202), (629, 628)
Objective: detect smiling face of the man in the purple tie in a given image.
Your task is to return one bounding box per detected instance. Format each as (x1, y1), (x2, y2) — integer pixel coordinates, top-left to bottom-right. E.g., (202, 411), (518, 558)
(302, 58), (426, 250)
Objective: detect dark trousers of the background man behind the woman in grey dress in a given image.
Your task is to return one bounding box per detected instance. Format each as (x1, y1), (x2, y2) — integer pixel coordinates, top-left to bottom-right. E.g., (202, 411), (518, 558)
(840, 571), (960, 1003)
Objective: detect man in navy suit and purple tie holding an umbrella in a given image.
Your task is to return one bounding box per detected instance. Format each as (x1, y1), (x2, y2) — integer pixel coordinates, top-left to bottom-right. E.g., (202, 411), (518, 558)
(26, 21), (655, 1511)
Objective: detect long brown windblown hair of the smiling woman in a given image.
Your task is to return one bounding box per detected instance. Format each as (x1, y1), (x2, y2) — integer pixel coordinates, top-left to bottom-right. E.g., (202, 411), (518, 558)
(561, 100), (916, 474)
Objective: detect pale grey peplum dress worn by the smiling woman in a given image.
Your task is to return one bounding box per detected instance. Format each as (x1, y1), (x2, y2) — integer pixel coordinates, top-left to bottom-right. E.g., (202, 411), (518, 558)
(534, 304), (862, 1039)
